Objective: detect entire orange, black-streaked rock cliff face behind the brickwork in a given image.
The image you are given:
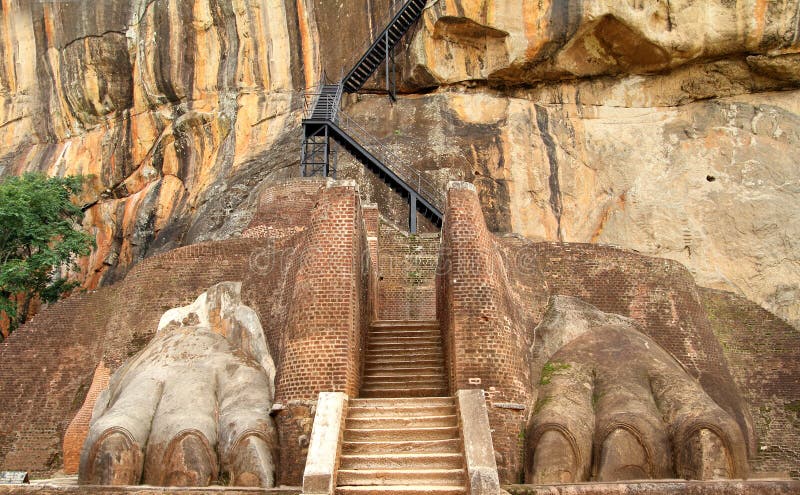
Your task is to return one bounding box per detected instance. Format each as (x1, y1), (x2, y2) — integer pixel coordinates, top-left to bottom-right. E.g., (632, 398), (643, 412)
(0, 0), (800, 326)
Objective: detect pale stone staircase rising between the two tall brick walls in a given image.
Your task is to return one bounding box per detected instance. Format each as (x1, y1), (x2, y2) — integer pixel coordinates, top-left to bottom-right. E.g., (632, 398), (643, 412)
(336, 321), (466, 495)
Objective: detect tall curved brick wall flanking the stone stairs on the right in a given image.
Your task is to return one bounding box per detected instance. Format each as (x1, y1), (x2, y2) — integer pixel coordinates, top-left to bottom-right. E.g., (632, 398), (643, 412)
(437, 185), (545, 482)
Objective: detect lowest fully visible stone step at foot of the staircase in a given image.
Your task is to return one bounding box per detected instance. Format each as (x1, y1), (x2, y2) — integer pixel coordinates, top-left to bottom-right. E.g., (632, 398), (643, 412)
(337, 469), (464, 486)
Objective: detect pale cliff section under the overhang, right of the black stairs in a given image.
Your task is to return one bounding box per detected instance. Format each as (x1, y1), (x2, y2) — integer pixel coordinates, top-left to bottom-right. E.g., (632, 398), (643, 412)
(338, 82), (800, 326)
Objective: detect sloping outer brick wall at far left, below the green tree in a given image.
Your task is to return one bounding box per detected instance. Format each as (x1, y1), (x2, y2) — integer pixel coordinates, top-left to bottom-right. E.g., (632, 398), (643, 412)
(0, 288), (116, 476)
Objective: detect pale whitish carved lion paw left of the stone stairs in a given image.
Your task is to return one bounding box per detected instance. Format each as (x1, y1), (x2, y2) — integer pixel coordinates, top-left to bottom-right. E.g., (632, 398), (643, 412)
(79, 282), (277, 487)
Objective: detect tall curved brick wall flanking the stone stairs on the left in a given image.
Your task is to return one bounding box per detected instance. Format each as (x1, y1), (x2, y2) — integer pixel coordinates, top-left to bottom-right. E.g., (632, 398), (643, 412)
(276, 181), (371, 485)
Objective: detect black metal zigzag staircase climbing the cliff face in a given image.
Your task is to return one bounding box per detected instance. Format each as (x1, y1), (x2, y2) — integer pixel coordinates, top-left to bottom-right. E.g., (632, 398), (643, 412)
(300, 0), (444, 233)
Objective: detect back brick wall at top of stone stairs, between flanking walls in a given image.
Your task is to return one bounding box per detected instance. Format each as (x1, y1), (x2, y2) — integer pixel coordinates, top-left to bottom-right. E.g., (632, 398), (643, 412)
(377, 217), (440, 320)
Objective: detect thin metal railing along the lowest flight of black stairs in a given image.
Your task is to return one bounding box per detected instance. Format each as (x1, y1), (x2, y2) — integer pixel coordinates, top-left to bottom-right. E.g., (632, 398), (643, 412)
(337, 111), (445, 211)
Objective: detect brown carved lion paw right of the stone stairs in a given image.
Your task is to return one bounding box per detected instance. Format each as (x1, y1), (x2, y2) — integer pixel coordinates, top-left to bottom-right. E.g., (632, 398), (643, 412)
(525, 296), (747, 484)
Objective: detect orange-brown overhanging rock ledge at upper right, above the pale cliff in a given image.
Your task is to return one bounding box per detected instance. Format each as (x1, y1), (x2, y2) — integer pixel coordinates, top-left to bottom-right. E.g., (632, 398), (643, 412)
(406, 0), (800, 87)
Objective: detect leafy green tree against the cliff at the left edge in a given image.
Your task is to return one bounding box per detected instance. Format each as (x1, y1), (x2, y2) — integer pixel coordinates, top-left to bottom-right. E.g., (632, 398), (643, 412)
(0, 173), (94, 341)
